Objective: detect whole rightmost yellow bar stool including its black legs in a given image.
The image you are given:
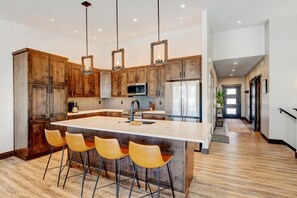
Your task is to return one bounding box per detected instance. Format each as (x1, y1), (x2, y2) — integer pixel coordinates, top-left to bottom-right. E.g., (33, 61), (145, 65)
(129, 141), (175, 197)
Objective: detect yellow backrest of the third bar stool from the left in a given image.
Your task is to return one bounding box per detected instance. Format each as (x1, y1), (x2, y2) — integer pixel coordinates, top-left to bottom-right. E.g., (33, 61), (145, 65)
(95, 136), (123, 160)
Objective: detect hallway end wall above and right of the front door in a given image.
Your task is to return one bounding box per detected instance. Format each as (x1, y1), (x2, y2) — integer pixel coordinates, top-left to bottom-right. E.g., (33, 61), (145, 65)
(218, 76), (246, 117)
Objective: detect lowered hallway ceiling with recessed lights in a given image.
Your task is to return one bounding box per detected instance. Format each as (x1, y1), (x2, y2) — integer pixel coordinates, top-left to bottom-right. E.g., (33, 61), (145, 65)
(214, 56), (263, 77)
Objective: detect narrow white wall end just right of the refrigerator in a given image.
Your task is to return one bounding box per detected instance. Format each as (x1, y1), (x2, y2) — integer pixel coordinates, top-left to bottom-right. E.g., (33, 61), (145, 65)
(202, 11), (217, 125)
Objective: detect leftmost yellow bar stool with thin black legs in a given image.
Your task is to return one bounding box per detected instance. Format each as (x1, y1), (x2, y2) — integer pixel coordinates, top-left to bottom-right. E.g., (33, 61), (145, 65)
(42, 129), (67, 186)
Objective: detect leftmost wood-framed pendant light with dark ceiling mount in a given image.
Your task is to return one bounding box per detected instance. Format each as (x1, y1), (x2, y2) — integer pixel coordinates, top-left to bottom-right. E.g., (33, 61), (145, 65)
(81, 1), (93, 74)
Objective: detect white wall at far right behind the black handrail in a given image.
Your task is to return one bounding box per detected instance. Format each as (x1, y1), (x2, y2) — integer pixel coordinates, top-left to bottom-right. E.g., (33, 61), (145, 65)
(269, 15), (297, 147)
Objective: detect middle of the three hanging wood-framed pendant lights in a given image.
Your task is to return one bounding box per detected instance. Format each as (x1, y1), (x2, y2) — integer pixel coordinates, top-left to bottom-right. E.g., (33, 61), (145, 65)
(111, 0), (125, 70)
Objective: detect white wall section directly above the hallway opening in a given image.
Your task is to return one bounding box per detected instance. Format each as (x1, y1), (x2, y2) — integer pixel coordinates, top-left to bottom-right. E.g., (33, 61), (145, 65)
(213, 25), (265, 60)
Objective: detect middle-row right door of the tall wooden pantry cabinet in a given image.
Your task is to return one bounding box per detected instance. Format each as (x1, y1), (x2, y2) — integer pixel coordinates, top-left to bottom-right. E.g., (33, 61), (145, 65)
(49, 85), (67, 119)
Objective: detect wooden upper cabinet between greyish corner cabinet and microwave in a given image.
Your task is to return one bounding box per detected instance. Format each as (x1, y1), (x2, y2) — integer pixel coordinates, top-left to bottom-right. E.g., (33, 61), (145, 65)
(111, 70), (128, 97)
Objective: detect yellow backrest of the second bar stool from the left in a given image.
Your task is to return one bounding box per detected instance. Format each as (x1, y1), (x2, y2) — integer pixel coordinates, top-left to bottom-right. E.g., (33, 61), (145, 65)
(65, 132), (89, 152)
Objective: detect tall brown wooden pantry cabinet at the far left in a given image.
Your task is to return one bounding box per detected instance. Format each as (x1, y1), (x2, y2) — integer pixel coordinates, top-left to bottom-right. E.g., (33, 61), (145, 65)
(13, 48), (68, 160)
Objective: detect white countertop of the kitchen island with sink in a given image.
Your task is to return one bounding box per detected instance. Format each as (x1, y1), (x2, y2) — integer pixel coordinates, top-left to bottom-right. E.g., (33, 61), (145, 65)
(51, 116), (211, 142)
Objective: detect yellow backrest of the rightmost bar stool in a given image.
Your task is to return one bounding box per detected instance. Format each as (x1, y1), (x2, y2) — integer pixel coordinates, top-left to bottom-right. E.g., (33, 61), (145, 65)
(129, 141), (165, 168)
